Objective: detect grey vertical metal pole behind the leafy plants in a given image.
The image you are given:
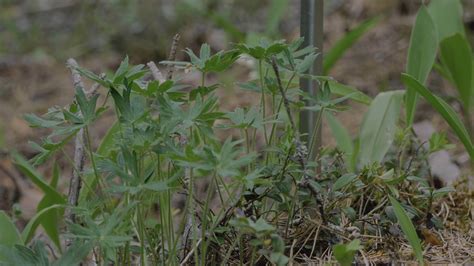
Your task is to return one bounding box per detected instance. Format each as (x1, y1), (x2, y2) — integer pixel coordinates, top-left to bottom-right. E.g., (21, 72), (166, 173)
(300, 0), (324, 159)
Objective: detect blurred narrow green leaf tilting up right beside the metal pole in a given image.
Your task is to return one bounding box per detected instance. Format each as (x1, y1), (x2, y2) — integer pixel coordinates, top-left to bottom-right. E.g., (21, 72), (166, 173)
(323, 17), (380, 75)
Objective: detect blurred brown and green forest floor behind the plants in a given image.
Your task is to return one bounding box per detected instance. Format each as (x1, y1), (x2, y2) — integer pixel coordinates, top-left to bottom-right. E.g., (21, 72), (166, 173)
(0, 0), (474, 215)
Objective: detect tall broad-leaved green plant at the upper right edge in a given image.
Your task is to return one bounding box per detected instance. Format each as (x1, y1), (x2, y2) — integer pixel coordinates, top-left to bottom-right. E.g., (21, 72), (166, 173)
(402, 0), (474, 160)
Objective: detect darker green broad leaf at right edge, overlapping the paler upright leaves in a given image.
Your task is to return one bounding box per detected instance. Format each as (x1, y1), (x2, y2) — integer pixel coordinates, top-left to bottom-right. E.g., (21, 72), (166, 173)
(440, 33), (474, 110)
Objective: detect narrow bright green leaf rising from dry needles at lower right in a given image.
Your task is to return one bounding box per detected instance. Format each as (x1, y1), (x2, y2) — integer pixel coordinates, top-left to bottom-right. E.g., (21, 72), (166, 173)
(388, 196), (424, 265)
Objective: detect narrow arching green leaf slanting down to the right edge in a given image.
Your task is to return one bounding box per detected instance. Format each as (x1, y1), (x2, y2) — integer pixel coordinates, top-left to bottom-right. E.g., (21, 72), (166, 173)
(402, 73), (474, 160)
